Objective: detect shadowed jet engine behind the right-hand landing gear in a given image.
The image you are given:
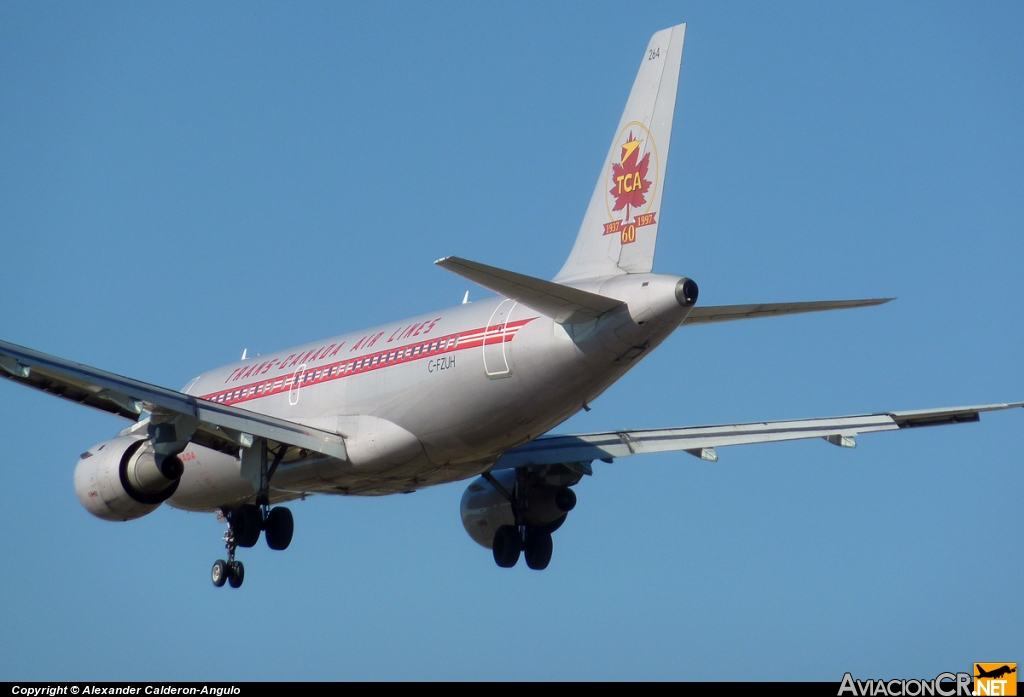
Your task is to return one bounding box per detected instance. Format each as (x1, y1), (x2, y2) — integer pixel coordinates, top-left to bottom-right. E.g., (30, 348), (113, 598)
(460, 470), (575, 550)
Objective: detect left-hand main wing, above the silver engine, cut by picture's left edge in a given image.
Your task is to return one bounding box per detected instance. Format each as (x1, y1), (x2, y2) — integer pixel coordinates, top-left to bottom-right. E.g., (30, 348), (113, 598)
(0, 341), (347, 460)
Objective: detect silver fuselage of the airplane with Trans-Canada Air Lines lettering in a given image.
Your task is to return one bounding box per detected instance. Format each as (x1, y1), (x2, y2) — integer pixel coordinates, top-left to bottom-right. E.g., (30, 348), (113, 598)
(169, 274), (689, 511)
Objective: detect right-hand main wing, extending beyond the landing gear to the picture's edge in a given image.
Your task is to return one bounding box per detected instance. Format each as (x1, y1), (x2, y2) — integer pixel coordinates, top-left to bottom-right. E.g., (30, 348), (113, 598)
(492, 402), (1024, 470)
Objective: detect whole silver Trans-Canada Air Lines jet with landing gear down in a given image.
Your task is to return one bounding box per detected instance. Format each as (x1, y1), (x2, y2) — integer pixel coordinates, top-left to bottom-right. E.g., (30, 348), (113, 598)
(0, 25), (1024, 587)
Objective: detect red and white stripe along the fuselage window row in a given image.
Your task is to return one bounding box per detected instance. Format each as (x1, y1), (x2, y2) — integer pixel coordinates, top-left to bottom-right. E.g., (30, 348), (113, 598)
(200, 317), (537, 404)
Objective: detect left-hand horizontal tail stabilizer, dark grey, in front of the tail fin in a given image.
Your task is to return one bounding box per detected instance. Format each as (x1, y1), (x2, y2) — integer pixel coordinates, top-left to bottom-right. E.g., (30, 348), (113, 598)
(434, 257), (624, 324)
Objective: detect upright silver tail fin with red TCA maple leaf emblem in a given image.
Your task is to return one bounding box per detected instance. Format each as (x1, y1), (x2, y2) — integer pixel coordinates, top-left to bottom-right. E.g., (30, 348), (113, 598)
(555, 25), (686, 282)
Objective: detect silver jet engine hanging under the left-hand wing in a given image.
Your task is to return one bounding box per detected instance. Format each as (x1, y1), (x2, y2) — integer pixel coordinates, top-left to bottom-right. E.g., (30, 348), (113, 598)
(75, 436), (184, 521)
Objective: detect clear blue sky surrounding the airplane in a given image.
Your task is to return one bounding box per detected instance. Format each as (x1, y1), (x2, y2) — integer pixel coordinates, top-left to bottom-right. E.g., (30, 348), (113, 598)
(0, 2), (1024, 681)
